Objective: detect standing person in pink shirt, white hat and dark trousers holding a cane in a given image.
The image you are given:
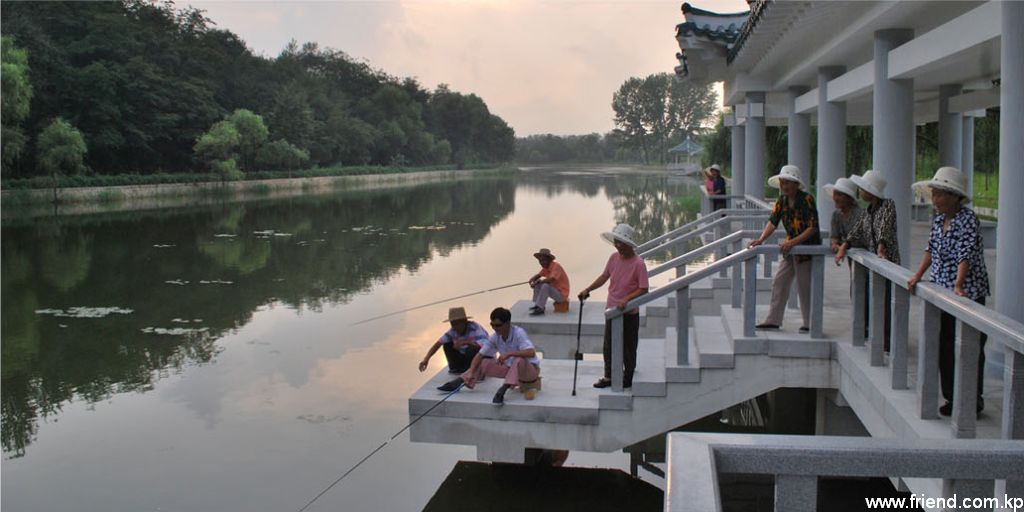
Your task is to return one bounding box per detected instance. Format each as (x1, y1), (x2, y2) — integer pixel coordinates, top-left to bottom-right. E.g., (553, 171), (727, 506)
(580, 224), (650, 388)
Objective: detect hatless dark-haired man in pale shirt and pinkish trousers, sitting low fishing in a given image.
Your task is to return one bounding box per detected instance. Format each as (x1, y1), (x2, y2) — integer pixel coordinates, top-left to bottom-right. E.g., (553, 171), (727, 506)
(438, 307), (541, 406)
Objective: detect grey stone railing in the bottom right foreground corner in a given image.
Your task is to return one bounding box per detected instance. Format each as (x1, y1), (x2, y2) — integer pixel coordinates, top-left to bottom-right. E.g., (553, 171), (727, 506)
(665, 432), (1024, 512)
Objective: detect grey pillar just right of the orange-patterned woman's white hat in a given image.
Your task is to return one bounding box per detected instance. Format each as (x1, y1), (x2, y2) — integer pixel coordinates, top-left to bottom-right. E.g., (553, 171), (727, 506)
(808, 67), (846, 225)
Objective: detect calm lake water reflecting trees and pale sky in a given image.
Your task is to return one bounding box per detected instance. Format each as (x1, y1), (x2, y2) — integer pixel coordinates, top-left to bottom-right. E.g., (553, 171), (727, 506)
(0, 168), (698, 512)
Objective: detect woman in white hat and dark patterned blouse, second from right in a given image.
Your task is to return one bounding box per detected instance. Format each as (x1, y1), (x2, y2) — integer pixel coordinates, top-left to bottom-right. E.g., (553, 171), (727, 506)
(836, 170), (899, 352)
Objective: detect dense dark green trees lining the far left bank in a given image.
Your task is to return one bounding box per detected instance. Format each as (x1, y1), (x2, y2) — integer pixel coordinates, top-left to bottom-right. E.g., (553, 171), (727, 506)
(0, 0), (515, 181)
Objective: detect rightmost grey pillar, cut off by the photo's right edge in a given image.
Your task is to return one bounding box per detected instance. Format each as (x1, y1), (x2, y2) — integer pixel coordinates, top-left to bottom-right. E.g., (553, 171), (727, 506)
(992, 2), (1024, 374)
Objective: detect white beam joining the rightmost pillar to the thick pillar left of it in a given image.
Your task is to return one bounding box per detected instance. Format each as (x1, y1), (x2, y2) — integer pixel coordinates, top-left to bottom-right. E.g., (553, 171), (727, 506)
(889, 1), (1002, 79)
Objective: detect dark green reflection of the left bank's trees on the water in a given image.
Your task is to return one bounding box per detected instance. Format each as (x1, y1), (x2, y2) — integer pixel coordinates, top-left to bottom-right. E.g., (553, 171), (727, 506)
(0, 179), (515, 457)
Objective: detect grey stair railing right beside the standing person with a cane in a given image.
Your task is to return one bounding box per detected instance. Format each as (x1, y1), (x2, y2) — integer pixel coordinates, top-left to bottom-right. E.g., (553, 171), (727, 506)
(604, 240), (831, 392)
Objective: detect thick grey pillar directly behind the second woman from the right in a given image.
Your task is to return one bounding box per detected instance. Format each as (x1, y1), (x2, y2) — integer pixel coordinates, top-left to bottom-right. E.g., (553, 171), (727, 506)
(861, 29), (921, 267)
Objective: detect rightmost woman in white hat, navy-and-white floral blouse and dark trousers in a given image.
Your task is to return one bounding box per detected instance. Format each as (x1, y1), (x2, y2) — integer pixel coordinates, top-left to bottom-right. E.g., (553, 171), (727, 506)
(906, 167), (989, 416)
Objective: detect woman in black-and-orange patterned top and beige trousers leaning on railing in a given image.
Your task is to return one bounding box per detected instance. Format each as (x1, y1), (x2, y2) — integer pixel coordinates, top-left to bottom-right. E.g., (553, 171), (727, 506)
(748, 165), (821, 333)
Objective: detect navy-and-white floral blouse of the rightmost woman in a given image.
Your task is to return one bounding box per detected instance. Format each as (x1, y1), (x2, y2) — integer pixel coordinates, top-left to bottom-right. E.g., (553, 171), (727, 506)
(925, 204), (989, 301)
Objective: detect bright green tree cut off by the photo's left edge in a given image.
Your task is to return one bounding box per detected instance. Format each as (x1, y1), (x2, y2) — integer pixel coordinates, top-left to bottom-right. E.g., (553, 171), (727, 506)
(0, 36), (32, 175)
